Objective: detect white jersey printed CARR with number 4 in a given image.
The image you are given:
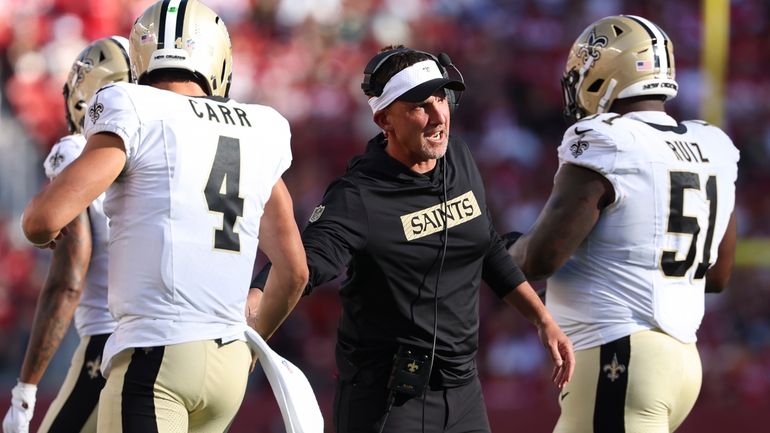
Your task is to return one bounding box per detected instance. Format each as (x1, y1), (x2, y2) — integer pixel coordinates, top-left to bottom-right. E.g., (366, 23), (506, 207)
(85, 83), (291, 371)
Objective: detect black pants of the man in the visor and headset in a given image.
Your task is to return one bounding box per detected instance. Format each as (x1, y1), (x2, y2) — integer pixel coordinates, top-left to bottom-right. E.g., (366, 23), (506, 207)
(334, 377), (490, 433)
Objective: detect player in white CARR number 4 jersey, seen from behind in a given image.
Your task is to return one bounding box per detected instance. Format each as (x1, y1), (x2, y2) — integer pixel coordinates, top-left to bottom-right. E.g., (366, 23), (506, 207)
(18, 0), (308, 433)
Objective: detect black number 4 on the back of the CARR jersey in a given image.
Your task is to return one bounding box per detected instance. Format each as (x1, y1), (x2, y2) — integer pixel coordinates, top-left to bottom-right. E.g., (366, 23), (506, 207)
(203, 136), (243, 252)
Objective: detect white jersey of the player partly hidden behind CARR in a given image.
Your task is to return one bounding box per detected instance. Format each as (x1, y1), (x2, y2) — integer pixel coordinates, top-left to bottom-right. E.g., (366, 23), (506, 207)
(43, 134), (116, 337)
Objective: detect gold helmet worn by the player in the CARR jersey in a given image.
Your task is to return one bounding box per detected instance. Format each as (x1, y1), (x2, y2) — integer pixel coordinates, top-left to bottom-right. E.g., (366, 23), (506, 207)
(129, 0), (233, 97)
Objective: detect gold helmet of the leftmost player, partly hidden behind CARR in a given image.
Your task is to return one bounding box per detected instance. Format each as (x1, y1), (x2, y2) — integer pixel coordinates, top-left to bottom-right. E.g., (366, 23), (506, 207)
(64, 36), (131, 134)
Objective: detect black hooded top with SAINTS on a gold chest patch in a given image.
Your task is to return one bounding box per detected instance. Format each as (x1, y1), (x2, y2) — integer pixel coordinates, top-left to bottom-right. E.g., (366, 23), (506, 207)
(292, 134), (525, 386)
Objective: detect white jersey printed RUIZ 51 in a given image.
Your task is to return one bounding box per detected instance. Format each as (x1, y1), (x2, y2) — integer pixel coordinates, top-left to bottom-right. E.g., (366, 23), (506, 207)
(546, 111), (739, 350)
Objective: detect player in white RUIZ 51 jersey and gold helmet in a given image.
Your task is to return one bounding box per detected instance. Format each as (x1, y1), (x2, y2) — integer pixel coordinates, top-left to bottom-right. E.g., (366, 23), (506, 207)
(510, 15), (739, 433)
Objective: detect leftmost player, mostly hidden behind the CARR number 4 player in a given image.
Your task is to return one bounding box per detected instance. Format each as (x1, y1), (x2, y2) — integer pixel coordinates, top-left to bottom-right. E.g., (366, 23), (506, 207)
(3, 36), (131, 433)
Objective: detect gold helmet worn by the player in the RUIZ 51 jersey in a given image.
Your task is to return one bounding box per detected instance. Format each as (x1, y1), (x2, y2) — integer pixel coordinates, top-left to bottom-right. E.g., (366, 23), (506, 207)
(561, 15), (678, 121)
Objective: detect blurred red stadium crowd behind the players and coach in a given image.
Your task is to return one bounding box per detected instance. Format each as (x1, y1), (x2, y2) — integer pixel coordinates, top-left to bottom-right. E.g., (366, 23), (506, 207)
(0, 0), (770, 433)
